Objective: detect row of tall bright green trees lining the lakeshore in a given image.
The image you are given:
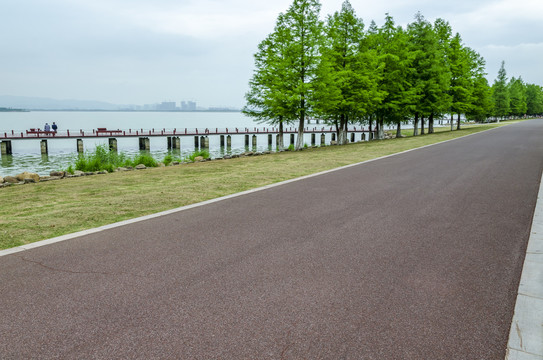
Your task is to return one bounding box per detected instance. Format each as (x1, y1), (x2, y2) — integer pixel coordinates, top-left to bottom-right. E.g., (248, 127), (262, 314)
(243, 0), (543, 149)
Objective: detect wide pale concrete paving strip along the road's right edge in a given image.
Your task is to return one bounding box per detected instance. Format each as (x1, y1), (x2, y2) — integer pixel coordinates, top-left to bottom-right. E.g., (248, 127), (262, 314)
(505, 169), (543, 360)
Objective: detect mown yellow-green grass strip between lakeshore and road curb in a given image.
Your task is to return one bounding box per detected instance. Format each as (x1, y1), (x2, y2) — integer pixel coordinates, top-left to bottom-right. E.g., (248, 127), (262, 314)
(0, 123), (510, 249)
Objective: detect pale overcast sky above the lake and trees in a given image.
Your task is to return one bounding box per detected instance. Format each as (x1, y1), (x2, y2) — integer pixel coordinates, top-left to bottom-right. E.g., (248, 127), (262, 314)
(0, 0), (543, 107)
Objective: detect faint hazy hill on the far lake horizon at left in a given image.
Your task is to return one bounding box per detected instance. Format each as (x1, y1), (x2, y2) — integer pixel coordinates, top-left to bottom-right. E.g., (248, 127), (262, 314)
(0, 95), (126, 110)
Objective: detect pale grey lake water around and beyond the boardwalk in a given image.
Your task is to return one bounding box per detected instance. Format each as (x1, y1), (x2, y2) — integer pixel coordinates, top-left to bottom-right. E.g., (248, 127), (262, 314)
(0, 111), (359, 176)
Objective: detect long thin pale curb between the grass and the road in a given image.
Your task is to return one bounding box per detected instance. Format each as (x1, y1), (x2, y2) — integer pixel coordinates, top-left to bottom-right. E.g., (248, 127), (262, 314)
(0, 124), (512, 257)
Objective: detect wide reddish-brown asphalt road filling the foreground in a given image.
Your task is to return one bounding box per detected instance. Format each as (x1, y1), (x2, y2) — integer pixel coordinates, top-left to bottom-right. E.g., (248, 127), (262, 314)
(0, 121), (543, 360)
